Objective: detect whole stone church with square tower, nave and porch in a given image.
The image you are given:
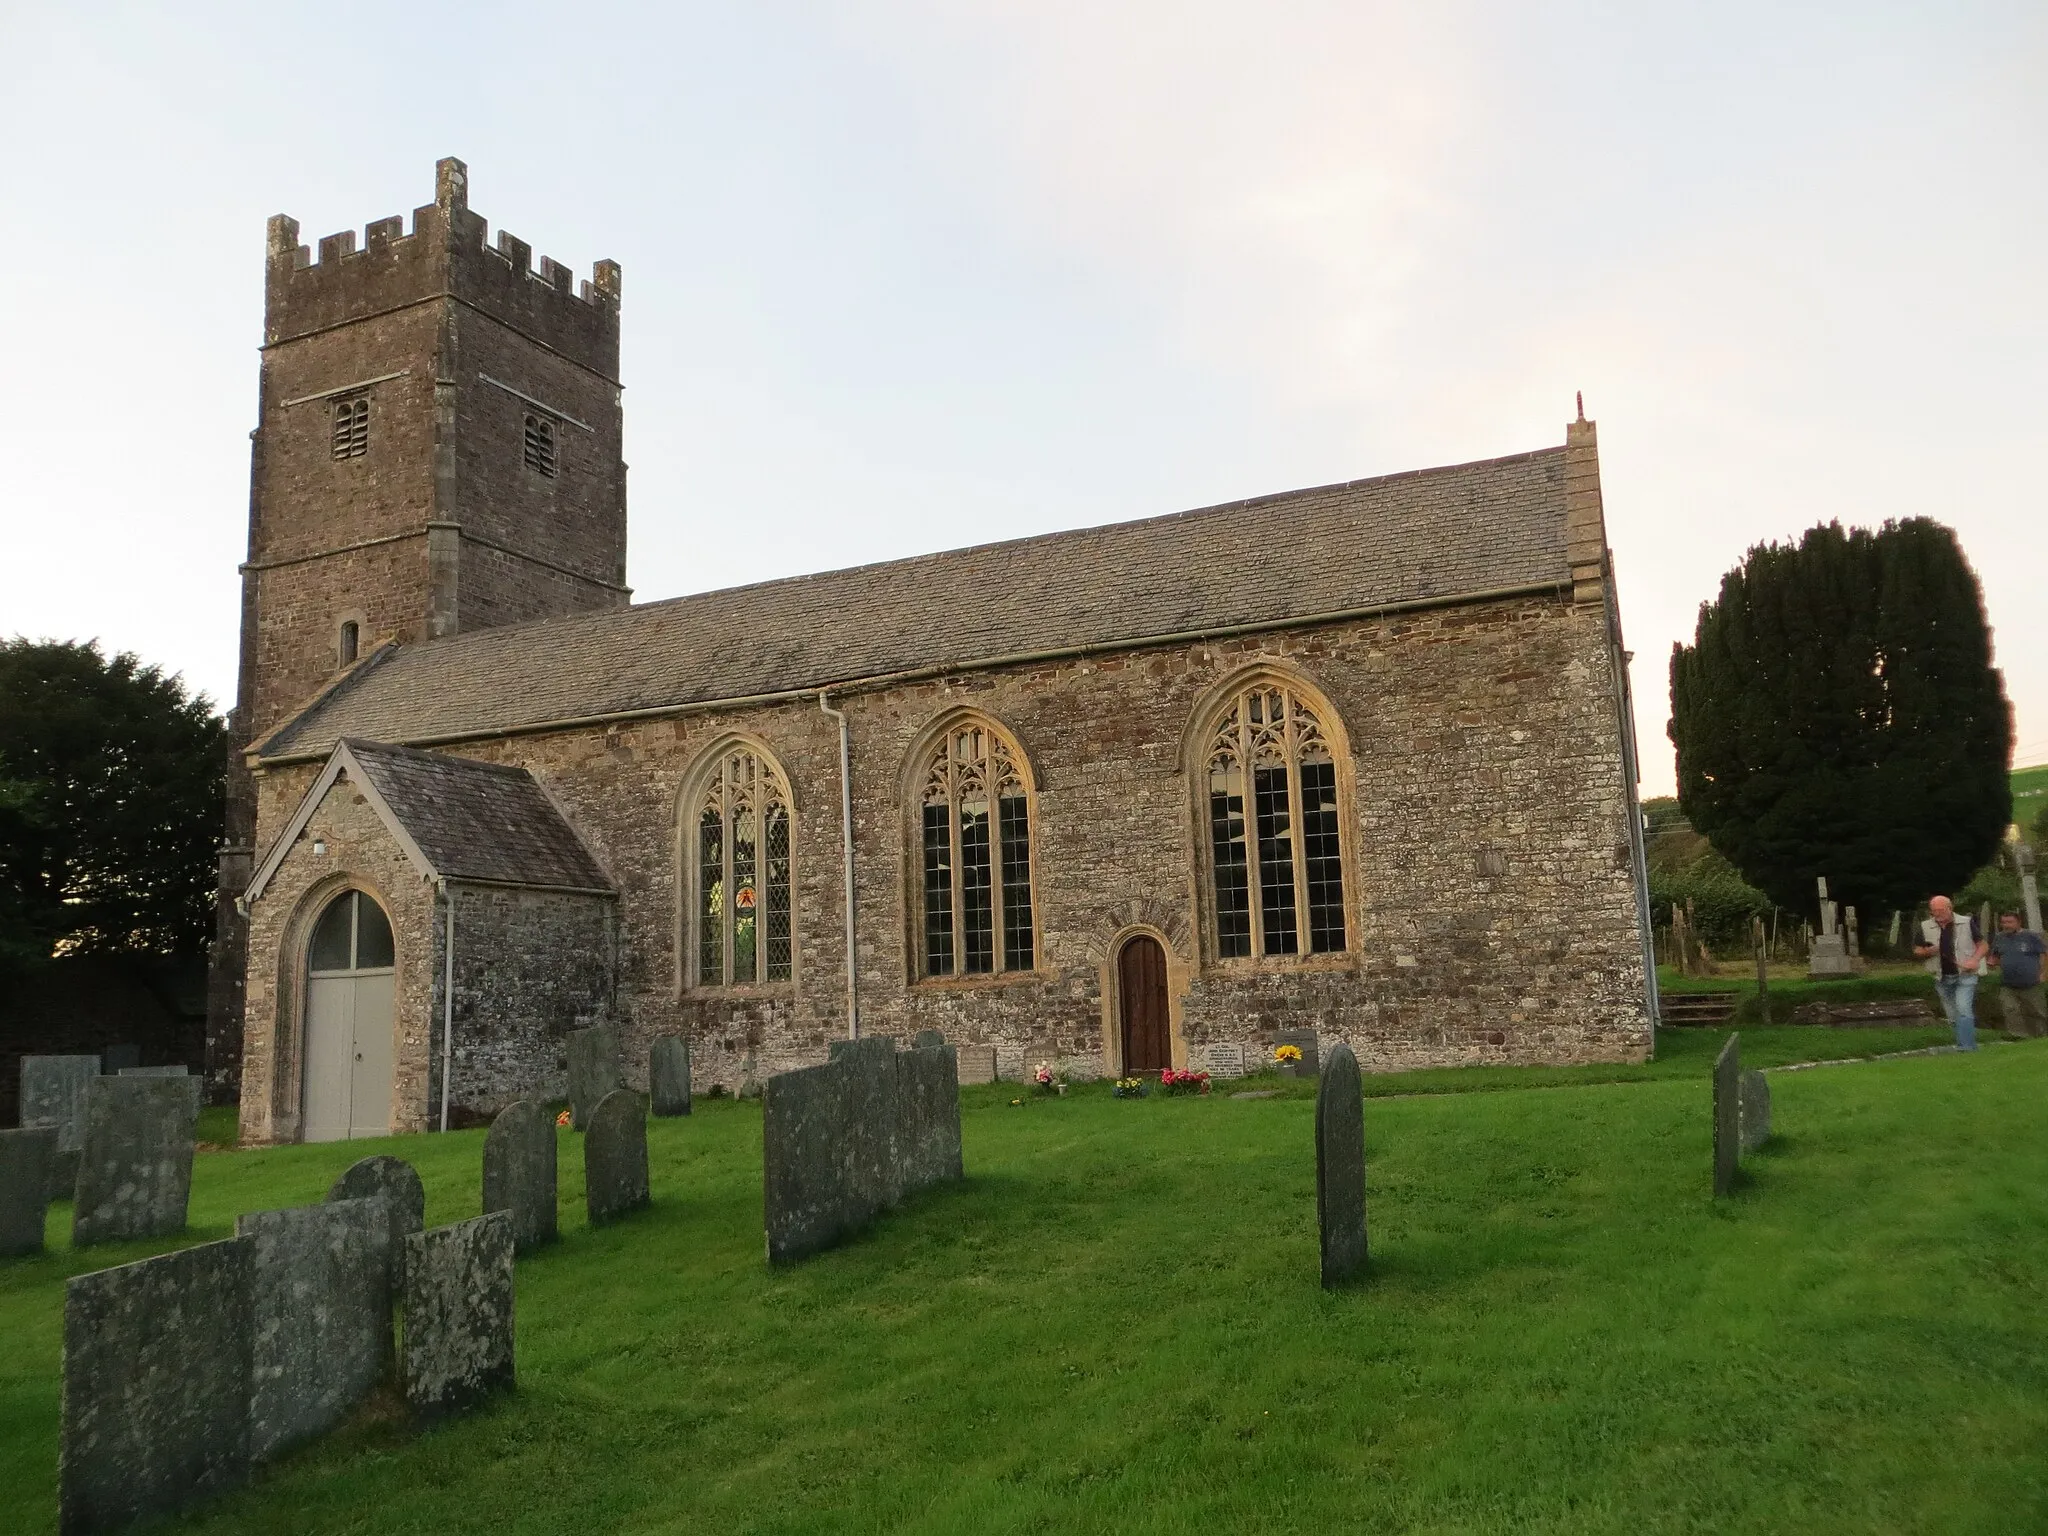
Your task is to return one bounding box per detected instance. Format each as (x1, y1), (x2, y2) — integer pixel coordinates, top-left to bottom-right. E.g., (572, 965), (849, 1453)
(209, 160), (1657, 1143)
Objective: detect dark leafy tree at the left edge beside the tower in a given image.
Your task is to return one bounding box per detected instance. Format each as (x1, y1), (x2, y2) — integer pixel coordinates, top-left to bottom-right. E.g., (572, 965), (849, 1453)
(0, 639), (227, 965)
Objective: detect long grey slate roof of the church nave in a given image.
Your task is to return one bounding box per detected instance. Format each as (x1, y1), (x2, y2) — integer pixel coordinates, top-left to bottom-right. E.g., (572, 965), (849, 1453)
(260, 446), (1571, 762)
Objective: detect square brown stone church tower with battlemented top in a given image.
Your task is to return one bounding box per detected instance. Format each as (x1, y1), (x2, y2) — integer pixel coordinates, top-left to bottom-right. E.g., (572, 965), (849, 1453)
(207, 160), (629, 1096)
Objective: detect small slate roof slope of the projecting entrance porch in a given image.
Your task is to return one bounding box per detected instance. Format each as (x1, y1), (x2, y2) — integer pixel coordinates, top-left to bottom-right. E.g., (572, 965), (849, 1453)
(342, 737), (612, 891)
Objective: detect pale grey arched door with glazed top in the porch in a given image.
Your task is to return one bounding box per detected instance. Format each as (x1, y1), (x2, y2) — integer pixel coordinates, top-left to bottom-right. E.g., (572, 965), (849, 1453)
(303, 891), (397, 1141)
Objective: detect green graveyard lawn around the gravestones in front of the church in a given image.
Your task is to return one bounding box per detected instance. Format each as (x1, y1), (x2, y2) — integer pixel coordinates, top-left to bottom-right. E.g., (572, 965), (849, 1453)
(0, 1030), (2048, 1536)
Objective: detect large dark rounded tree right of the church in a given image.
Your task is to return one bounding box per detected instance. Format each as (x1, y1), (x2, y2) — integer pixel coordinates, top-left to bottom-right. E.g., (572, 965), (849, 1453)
(1671, 518), (2013, 924)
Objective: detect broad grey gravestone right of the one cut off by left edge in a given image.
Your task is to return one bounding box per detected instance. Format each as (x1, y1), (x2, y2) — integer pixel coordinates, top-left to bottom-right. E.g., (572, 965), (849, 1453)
(72, 1077), (199, 1247)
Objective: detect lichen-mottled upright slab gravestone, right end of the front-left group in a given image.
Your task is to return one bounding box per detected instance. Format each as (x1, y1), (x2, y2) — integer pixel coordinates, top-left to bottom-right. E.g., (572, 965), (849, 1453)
(399, 1210), (512, 1419)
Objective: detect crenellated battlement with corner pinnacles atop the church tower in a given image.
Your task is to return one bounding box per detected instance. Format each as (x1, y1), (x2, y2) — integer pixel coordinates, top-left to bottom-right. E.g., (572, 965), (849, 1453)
(264, 158), (621, 379)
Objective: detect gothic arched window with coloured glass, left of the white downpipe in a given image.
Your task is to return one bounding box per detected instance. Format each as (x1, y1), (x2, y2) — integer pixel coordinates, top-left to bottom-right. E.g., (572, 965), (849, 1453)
(684, 745), (793, 987)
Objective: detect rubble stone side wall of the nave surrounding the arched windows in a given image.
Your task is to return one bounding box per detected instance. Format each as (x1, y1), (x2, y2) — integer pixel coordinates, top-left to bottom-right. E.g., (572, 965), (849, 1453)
(250, 598), (1651, 1130)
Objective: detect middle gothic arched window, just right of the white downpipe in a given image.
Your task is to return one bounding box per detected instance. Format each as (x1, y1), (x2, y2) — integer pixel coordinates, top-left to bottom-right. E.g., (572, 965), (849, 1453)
(918, 719), (1038, 977)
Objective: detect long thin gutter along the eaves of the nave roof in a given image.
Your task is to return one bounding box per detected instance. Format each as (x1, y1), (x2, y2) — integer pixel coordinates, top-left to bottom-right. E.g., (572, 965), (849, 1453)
(246, 575), (1571, 768)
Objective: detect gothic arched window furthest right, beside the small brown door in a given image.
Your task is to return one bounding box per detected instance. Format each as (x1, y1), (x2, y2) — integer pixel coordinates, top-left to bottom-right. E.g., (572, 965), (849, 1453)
(1206, 682), (1343, 958)
